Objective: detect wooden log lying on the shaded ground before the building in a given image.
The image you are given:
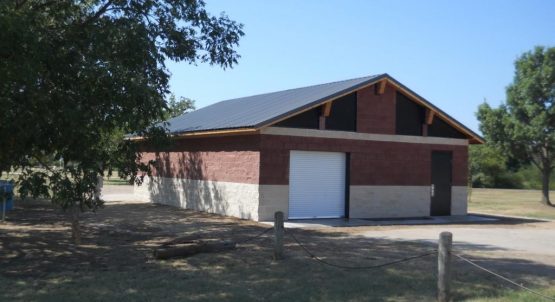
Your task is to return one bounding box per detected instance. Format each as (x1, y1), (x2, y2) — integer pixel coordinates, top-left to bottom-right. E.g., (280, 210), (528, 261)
(154, 240), (236, 259)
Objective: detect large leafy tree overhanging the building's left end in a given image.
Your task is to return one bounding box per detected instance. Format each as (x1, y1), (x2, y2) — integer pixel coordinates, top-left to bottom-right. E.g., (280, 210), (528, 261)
(0, 0), (243, 243)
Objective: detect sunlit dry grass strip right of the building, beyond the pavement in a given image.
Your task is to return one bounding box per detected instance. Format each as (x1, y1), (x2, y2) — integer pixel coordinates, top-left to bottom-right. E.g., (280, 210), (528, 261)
(468, 189), (555, 219)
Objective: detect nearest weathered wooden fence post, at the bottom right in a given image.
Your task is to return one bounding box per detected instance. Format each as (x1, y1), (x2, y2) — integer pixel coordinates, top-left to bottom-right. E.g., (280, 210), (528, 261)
(437, 232), (453, 302)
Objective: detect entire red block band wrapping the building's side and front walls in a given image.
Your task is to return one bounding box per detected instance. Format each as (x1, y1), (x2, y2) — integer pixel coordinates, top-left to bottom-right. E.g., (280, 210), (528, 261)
(137, 135), (468, 186)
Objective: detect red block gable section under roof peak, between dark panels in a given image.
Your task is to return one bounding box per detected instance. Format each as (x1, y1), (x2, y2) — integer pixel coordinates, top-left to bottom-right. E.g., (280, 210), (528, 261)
(357, 84), (396, 134)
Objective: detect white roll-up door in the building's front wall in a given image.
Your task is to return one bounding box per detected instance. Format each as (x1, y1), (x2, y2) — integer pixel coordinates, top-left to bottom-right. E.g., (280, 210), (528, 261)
(289, 151), (346, 219)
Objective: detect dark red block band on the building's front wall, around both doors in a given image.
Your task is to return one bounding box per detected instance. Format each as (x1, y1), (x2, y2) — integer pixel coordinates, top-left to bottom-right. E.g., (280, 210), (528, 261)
(260, 135), (468, 186)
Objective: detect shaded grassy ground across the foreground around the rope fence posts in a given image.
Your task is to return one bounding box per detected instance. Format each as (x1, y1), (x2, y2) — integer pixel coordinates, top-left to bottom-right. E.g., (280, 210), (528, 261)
(0, 195), (555, 302)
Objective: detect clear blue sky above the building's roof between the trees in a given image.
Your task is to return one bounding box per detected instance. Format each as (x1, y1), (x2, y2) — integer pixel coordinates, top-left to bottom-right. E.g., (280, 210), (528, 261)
(168, 0), (555, 130)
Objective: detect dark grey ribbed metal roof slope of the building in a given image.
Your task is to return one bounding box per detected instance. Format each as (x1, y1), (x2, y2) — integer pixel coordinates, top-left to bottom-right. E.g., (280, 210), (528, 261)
(164, 74), (387, 134)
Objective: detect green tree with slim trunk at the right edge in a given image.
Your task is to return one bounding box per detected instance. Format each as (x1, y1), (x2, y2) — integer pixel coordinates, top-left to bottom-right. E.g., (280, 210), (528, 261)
(478, 47), (555, 206)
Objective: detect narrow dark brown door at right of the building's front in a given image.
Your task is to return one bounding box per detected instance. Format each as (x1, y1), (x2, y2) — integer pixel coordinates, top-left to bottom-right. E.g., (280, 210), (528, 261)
(430, 151), (453, 216)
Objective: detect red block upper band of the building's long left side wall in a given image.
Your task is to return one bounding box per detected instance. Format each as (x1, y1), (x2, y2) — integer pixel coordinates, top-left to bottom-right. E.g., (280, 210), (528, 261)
(139, 135), (260, 184)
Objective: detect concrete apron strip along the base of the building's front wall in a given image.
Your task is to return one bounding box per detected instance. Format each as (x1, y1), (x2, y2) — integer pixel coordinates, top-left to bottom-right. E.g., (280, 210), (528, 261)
(261, 215), (499, 228)
